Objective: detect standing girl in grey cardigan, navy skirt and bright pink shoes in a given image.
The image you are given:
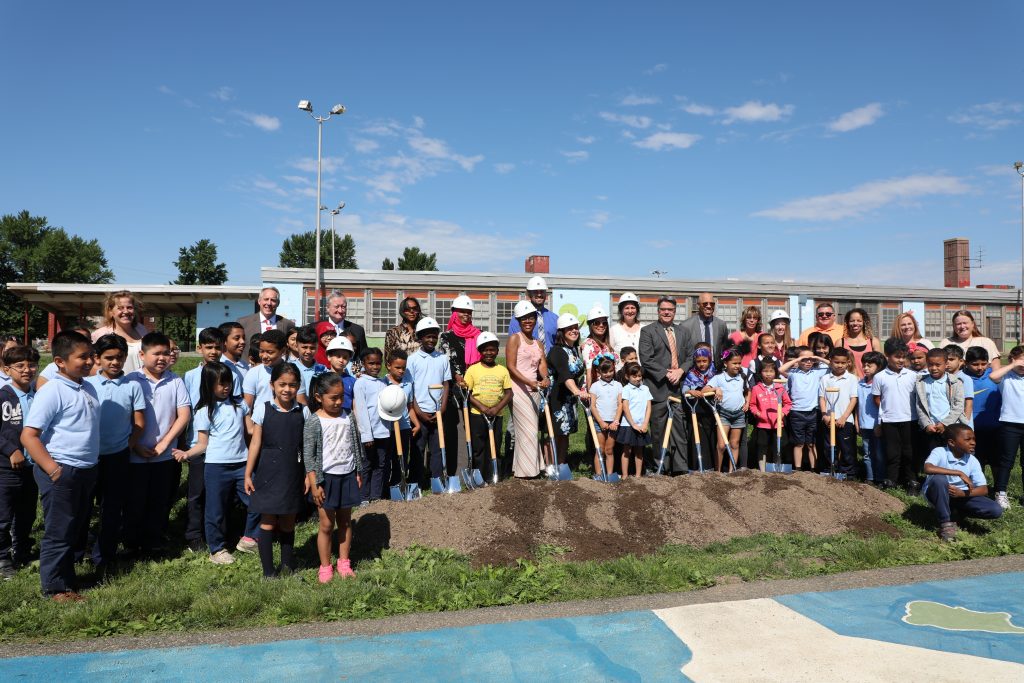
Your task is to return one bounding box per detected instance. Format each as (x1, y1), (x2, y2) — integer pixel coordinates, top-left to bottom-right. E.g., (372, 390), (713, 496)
(302, 373), (370, 584)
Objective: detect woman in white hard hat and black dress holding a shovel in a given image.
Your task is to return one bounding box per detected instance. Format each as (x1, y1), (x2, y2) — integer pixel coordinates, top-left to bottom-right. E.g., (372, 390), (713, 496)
(548, 313), (590, 467)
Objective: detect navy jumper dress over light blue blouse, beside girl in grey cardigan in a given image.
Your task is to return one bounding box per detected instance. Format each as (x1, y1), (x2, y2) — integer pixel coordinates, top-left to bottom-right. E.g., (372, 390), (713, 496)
(249, 401), (309, 515)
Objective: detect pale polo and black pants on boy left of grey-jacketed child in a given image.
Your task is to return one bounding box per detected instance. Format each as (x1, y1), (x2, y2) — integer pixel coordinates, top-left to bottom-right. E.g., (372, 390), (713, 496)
(871, 368), (918, 484)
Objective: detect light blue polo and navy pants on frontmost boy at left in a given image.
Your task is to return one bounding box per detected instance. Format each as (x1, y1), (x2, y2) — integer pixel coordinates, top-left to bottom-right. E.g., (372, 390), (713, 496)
(25, 373), (99, 595)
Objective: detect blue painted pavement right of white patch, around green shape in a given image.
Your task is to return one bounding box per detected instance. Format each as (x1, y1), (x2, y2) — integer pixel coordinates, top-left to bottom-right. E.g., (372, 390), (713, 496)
(775, 573), (1024, 664)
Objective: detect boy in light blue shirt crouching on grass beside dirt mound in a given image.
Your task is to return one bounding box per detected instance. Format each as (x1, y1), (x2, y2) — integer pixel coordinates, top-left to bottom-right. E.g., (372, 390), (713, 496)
(923, 424), (1002, 541)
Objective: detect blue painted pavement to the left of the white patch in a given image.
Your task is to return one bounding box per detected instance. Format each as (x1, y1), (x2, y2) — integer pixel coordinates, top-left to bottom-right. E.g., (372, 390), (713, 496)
(0, 611), (691, 683)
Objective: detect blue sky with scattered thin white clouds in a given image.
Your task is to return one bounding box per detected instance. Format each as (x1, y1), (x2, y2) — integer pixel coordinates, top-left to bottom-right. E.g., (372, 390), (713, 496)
(0, 1), (1024, 286)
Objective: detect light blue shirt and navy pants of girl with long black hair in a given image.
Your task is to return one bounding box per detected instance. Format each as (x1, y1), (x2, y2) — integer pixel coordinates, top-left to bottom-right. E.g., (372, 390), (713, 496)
(195, 400), (259, 555)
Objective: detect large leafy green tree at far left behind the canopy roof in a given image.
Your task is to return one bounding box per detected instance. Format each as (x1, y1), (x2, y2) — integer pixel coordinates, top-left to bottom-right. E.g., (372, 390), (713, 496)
(0, 211), (114, 336)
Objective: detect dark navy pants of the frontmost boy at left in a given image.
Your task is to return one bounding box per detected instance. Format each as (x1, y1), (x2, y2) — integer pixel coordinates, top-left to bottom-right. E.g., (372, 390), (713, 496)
(32, 465), (97, 595)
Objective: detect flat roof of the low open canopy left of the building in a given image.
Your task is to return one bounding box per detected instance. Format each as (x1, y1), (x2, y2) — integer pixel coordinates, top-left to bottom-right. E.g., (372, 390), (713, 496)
(7, 283), (261, 315)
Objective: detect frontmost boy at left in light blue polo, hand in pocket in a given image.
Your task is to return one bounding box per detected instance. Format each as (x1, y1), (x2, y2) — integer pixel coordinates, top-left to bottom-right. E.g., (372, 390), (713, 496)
(22, 332), (99, 602)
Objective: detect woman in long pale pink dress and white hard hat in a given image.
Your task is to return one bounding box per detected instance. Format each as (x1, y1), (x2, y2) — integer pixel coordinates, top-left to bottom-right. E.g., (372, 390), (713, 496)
(505, 301), (550, 479)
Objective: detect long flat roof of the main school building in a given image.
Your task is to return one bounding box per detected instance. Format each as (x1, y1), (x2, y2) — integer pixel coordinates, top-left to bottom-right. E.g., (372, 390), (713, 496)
(260, 267), (1018, 305)
